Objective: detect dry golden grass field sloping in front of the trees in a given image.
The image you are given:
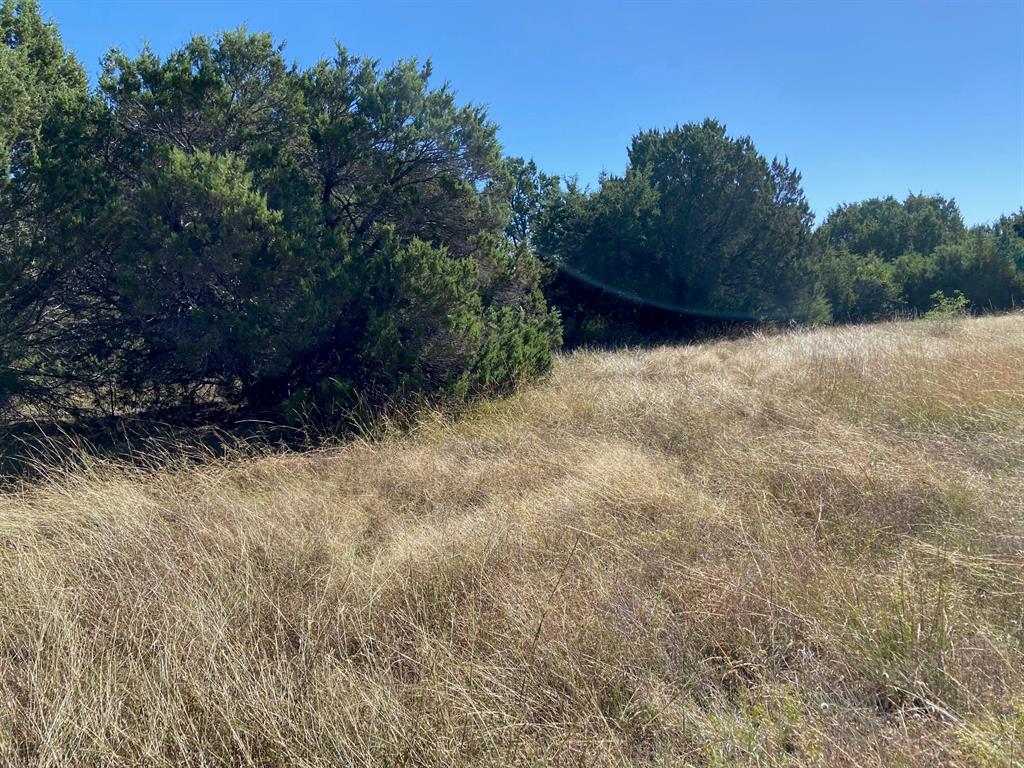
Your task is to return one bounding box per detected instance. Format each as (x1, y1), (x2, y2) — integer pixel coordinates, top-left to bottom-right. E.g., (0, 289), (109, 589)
(0, 313), (1024, 766)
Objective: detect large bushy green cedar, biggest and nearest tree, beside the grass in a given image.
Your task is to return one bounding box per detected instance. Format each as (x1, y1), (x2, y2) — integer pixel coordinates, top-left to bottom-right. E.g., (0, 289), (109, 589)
(5, 27), (559, 420)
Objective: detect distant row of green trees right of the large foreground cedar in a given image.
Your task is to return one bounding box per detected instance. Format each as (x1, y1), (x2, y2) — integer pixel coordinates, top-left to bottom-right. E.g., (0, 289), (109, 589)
(516, 120), (1024, 342)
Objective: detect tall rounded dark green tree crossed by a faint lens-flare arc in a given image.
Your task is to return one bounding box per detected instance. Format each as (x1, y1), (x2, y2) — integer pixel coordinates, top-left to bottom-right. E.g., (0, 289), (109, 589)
(537, 120), (820, 339)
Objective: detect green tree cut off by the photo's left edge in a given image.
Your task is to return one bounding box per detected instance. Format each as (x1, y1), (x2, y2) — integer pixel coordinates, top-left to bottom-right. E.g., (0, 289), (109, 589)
(0, 0), (88, 414)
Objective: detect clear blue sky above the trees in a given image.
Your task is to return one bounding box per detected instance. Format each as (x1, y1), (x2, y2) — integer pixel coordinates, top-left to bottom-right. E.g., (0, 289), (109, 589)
(42, 0), (1024, 223)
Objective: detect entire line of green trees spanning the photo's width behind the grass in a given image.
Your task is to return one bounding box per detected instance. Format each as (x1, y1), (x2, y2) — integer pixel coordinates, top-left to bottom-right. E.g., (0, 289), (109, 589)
(0, 0), (1024, 428)
